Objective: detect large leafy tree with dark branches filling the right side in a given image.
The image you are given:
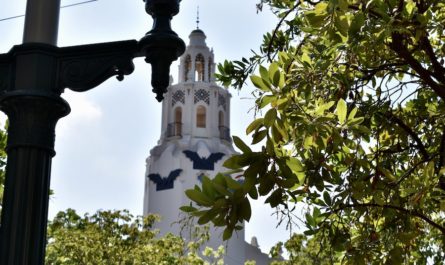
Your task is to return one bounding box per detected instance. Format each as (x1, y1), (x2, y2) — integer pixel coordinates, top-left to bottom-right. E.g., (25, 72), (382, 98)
(185, 0), (445, 264)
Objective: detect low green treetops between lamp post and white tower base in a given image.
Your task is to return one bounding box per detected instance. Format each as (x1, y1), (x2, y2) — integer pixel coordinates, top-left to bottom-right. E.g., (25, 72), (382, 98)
(45, 209), (224, 265)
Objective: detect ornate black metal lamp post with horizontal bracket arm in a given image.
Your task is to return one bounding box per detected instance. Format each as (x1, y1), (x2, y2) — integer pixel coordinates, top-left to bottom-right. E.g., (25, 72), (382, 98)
(0, 0), (185, 265)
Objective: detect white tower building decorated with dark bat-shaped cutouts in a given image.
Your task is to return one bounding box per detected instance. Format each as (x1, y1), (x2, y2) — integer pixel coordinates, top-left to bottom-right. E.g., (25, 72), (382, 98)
(144, 29), (269, 265)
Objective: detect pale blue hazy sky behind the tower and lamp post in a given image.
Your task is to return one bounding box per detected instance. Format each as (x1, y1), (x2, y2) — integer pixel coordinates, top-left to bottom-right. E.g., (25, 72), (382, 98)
(0, 0), (302, 251)
